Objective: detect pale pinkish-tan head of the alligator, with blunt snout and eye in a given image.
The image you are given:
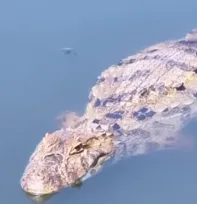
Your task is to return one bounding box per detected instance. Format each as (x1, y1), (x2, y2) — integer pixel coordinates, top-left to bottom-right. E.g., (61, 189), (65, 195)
(21, 130), (114, 195)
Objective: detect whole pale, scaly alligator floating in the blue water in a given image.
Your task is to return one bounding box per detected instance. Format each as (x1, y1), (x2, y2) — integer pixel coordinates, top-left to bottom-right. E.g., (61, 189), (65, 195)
(20, 29), (197, 195)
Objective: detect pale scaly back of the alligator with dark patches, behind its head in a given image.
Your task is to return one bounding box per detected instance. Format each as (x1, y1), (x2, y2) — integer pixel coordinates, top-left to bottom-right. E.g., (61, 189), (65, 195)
(85, 30), (197, 158)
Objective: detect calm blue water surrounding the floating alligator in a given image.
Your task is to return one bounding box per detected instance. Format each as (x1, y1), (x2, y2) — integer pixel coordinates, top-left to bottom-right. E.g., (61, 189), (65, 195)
(0, 0), (197, 204)
